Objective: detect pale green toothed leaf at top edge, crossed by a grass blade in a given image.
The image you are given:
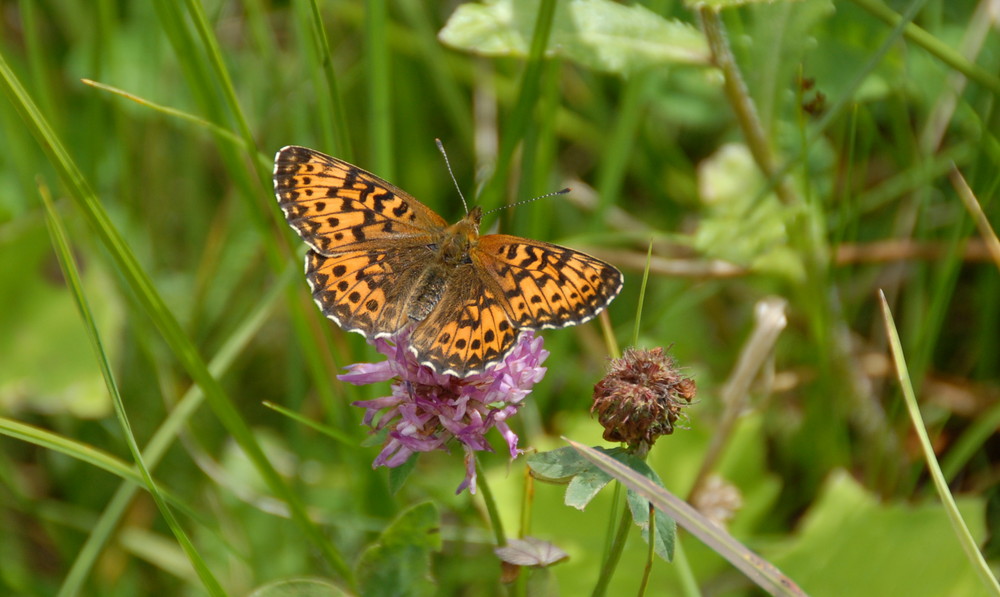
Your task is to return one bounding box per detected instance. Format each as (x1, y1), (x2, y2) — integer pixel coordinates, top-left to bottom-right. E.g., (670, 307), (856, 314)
(438, 0), (709, 75)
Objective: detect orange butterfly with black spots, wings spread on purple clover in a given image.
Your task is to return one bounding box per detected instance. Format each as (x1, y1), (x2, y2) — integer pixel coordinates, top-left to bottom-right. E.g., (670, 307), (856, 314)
(274, 146), (622, 377)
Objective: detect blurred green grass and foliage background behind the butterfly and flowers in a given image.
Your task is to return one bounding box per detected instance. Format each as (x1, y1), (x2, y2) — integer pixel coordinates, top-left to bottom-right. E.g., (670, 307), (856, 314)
(0, 0), (1000, 595)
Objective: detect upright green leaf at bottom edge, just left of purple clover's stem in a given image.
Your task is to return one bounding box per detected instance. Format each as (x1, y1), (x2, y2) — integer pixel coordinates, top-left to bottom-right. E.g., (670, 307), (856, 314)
(356, 502), (441, 597)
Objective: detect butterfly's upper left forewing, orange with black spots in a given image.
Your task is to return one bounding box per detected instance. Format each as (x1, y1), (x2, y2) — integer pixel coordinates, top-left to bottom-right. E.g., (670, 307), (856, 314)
(274, 146), (447, 255)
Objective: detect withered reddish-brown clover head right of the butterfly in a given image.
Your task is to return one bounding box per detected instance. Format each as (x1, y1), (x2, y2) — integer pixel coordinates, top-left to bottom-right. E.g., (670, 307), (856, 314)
(590, 347), (695, 448)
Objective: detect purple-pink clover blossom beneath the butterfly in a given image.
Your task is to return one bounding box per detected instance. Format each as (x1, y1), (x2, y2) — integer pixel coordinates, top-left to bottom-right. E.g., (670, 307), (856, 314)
(337, 330), (549, 493)
